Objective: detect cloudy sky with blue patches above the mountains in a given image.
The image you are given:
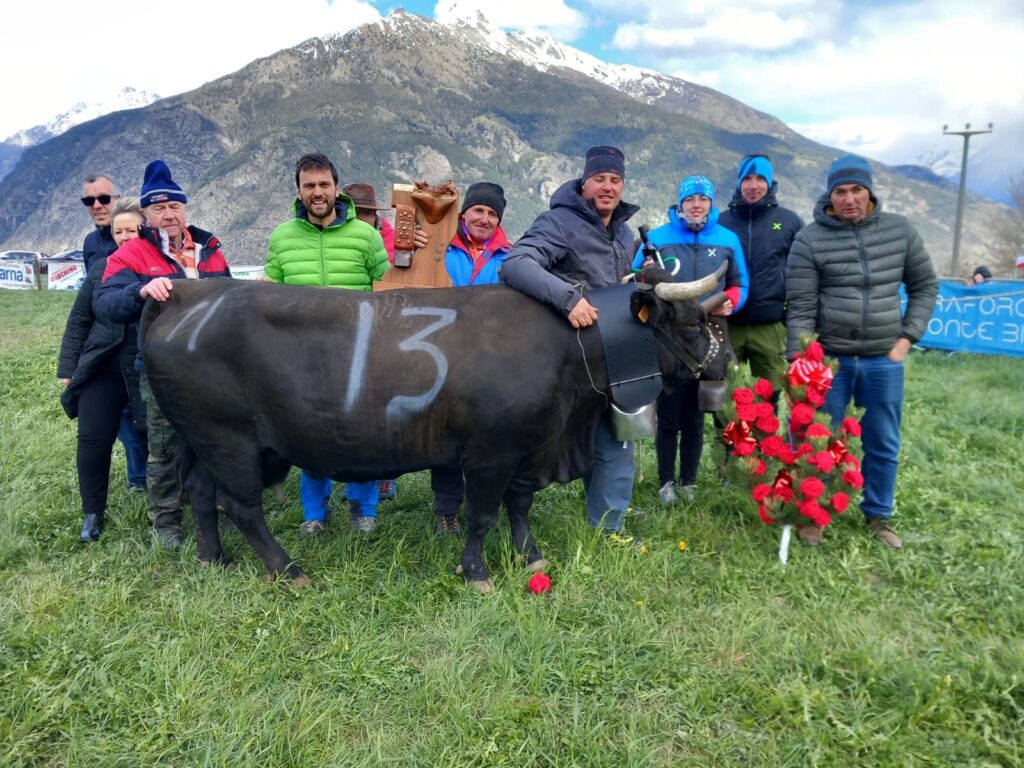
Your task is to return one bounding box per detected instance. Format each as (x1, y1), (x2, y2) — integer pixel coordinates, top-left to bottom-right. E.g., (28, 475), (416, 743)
(0, 0), (1024, 196)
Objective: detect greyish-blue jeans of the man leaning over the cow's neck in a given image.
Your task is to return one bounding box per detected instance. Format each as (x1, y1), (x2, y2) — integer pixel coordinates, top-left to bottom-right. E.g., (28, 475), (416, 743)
(583, 414), (636, 530)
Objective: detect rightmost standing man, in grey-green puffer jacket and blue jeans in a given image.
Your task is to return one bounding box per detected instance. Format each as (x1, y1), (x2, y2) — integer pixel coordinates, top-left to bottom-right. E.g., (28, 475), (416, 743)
(785, 156), (938, 549)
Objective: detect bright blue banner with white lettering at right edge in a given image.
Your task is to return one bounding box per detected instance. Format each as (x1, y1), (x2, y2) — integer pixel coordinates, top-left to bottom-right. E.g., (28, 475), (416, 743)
(904, 280), (1024, 357)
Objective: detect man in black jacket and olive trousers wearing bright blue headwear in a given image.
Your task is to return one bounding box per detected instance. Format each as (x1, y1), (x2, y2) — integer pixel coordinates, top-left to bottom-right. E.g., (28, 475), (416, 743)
(718, 155), (804, 397)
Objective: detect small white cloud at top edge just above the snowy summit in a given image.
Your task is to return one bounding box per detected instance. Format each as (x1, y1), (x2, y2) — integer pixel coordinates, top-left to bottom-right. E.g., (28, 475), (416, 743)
(434, 0), (587, 42)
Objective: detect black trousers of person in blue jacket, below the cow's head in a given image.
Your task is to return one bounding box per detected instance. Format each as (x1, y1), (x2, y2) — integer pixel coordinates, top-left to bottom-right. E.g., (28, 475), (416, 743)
(654, 379), (705, 485)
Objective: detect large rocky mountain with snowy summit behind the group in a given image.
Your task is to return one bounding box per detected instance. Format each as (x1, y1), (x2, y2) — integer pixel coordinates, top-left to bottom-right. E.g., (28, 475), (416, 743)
(0, 11), (999, 276)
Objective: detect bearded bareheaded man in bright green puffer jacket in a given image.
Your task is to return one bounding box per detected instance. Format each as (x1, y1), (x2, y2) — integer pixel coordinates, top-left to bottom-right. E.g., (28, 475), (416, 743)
(263, 153), (389, 538)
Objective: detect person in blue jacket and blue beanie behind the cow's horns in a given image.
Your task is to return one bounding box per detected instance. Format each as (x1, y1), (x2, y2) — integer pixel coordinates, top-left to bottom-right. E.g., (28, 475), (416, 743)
(633, 176), (749, 505)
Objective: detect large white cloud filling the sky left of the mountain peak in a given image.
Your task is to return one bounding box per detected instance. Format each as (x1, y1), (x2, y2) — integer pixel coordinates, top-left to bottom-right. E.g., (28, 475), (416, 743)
(0, 0), (380, 139)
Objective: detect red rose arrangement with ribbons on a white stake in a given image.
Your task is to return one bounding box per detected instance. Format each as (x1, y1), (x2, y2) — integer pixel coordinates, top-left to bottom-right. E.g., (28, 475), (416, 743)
(721, 341), (864, 563)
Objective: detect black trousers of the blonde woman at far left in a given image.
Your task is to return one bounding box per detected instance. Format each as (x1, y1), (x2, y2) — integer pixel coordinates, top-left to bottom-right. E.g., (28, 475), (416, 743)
(77, 354), (145, 515)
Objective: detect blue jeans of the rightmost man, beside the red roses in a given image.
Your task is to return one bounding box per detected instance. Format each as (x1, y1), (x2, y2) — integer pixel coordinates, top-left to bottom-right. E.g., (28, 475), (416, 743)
(824, 354), (903, 520)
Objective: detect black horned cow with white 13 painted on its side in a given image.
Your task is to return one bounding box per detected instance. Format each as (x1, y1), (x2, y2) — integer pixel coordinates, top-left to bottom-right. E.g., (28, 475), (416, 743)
(142, 270), (729, 591)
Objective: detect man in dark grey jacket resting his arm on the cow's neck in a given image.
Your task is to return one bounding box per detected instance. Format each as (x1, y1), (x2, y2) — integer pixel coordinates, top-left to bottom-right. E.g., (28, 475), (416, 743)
(501, 146), (645, 551)
